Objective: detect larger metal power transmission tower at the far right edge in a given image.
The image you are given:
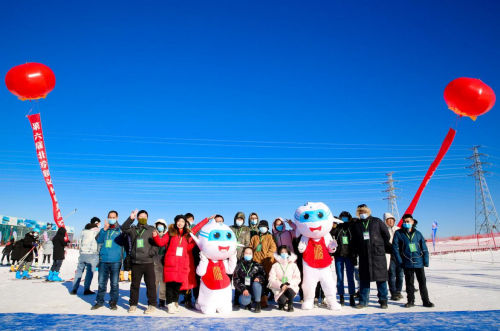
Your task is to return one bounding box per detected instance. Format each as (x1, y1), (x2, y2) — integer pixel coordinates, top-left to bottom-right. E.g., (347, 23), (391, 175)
(467, 146), (500, 235)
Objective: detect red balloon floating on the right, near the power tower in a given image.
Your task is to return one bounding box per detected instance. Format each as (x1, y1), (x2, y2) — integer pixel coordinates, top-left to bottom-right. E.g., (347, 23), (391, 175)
(444, 77), (496, 120)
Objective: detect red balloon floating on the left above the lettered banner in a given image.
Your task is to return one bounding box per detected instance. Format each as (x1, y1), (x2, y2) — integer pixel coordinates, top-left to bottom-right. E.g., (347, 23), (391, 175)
(5, 62), (56, 101)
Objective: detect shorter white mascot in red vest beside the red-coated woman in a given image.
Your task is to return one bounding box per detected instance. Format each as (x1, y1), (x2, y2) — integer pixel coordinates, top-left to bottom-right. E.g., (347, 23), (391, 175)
(191, 220), (237, 314)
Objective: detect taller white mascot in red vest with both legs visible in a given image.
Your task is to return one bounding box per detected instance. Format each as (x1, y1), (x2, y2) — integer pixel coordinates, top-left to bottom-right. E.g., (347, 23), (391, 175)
(295, 202), (342, 310)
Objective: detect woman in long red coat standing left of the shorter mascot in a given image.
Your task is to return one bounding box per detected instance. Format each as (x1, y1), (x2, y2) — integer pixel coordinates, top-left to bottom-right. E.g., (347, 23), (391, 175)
(153, 215), (214, 314)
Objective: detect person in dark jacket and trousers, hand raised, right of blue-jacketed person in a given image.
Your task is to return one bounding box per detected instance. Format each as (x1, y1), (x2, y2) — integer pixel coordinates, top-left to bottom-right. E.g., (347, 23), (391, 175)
(122, 209), (158, 314)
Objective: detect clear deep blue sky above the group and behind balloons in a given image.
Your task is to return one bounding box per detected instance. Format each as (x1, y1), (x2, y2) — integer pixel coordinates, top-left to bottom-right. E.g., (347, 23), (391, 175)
(0, 1), (500, 236)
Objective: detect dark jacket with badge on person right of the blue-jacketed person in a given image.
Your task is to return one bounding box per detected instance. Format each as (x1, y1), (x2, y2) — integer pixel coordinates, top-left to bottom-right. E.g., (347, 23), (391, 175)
(122, 217), (158, 264)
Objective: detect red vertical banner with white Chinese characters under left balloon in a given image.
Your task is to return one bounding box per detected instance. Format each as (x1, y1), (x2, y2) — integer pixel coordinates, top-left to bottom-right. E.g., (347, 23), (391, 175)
(28, 114), (68, 240)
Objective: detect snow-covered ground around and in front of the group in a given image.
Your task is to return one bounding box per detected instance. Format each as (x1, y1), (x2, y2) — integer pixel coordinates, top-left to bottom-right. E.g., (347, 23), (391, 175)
(0, 250), (500, 330)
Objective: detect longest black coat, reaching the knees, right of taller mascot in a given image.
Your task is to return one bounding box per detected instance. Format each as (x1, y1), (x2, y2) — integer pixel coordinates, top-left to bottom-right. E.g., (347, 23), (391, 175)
(351, 216), (392, 282)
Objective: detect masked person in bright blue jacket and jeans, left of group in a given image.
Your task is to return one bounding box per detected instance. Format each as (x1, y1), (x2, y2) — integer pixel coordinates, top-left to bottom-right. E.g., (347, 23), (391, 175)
(91, 210), (125, 310)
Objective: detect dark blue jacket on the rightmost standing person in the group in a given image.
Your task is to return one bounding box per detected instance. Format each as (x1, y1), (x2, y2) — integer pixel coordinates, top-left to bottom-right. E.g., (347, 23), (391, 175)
(392, 228), (429, 269)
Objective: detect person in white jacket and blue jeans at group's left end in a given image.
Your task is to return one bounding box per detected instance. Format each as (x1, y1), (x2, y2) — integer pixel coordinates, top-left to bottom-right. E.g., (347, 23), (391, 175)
(70, 221), (100, 295)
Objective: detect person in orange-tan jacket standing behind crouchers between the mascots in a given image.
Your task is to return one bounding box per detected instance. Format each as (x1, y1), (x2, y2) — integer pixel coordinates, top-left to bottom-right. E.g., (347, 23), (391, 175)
(250, 220), (276, 308)
